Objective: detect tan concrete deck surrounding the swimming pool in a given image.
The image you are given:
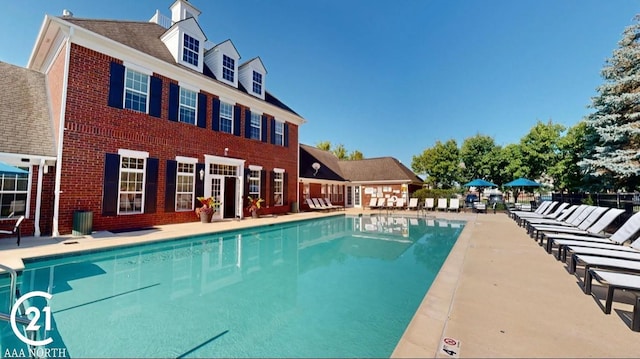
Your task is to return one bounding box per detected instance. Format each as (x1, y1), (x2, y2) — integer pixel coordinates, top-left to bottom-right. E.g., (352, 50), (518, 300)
(0, 209), (640, 358)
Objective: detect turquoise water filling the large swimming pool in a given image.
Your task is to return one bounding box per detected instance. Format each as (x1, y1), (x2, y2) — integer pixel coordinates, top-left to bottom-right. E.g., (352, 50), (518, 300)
(2, 216), (464, 358)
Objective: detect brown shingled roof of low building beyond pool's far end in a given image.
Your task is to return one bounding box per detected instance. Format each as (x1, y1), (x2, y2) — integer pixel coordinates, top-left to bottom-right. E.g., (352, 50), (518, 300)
(338, 157), (423, 183)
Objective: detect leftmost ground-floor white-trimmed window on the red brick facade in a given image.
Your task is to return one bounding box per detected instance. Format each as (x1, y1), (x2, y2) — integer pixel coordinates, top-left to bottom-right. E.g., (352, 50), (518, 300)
(118, 156), (146, 214)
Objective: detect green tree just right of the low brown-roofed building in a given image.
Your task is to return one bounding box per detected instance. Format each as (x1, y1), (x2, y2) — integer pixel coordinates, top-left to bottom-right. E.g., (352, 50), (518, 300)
(411, 139), (461, 188)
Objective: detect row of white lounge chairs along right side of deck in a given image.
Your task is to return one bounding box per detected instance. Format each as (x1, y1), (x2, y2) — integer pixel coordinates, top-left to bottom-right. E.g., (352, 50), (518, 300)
(509, 201), (640, 331)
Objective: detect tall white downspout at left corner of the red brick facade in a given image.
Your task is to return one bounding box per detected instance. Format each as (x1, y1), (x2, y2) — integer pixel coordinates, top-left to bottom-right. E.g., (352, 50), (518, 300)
(51, 27), (73, 237)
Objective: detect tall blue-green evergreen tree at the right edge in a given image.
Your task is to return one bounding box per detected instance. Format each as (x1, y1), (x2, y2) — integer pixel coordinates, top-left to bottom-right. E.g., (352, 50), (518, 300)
(580, 16), (640, 191)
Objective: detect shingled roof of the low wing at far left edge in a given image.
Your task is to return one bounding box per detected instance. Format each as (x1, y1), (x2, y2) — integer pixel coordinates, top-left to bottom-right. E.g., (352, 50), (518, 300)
(0, 62), (56, 157)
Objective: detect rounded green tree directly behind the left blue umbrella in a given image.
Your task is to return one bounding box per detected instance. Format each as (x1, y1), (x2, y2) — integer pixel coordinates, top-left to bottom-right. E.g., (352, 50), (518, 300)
(460, 134), (497, 182)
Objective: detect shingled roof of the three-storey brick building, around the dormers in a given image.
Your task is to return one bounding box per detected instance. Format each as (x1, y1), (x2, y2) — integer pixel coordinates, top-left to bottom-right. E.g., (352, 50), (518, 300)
(60, 17), (300, 116)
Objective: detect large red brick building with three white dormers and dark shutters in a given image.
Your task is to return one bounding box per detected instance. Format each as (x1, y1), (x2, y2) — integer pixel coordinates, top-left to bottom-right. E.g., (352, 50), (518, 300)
(0, 0), (305, 236)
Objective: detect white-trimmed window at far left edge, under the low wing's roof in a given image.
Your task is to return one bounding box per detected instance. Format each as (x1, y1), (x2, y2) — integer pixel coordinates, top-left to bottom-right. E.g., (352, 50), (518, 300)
(0, 167), (29, 218)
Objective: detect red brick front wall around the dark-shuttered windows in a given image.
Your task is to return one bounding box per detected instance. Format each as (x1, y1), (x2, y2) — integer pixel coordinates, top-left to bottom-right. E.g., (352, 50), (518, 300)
(53, 45), (298, 234)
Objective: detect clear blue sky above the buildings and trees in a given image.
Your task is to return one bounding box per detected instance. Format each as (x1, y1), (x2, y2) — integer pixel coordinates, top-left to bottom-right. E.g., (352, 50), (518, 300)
(0, 0), (640, 167)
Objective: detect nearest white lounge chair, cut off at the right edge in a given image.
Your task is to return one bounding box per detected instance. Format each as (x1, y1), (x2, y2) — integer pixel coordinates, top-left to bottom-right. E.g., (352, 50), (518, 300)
(590, 269), (640, 332)
